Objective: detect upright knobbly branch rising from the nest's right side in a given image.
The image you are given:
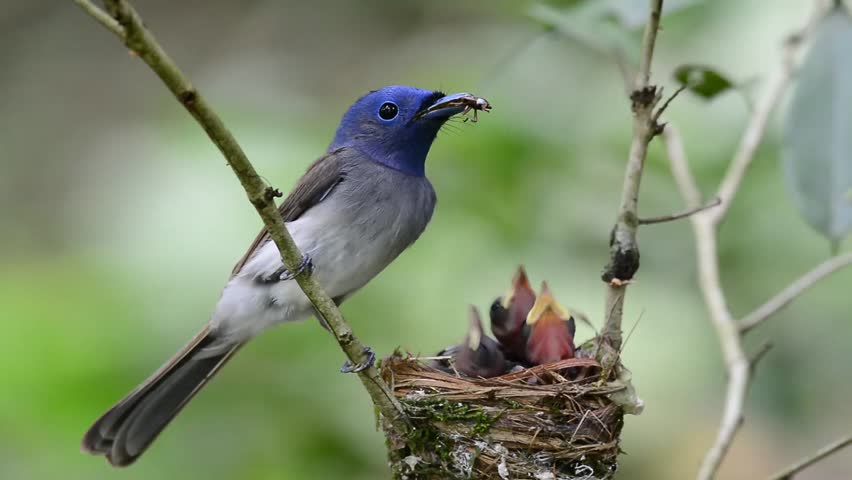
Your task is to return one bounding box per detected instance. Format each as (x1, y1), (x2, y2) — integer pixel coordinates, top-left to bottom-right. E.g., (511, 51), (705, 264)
(601, 0), (663, 351)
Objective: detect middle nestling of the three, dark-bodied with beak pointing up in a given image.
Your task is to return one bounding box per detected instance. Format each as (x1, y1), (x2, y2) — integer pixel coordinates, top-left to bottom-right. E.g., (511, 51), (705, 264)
(489, 266), (535, 363)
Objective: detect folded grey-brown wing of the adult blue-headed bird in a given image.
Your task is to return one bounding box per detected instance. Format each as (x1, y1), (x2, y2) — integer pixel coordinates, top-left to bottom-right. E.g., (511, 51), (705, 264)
(231, 149), (346, 276)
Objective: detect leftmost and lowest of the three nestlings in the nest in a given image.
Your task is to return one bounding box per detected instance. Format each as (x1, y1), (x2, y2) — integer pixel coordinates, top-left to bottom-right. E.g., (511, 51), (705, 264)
(453, 306), (508, 378)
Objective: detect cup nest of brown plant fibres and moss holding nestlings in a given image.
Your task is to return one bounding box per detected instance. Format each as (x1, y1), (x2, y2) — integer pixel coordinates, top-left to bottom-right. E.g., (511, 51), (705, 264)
(381, 347), (632, 480)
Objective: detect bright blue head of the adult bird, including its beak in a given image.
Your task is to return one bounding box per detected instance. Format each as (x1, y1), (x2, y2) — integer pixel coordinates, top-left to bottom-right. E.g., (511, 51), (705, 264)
(329, 86), (468, 176)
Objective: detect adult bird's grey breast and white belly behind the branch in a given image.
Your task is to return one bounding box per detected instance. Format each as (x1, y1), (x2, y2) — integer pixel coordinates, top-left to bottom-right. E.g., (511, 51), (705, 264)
(211, 152), (435, 344)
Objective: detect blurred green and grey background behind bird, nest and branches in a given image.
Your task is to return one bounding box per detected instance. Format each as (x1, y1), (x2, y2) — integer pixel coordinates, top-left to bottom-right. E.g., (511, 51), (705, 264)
(0, 0), (852, 480)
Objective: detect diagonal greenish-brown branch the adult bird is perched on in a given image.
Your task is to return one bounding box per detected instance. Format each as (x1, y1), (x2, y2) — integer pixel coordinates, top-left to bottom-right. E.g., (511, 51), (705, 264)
(75, 0), (409, 433)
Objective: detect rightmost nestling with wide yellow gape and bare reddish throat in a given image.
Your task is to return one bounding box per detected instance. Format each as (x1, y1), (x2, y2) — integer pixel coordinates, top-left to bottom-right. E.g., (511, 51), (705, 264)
(526, 282), (577, 365)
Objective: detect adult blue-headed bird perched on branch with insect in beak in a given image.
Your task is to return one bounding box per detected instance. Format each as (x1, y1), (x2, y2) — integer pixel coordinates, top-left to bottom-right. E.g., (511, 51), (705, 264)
(81, 85), (487, 466)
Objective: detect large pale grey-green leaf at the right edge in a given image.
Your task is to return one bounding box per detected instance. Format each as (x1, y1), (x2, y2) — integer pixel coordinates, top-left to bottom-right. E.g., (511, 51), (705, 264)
(781, 5), (852, 244)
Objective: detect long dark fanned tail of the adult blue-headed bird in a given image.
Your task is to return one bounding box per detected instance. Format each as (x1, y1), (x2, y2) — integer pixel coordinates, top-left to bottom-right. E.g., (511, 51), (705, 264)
(82, 327), (242, 466)
